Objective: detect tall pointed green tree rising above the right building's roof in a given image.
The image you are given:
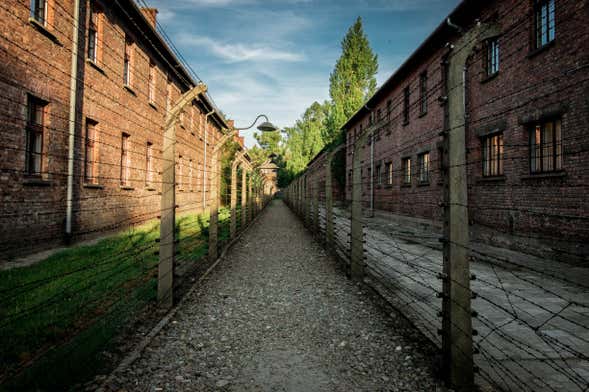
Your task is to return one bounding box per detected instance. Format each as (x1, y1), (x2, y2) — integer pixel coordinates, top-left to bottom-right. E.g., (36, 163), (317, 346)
(323, 17), (378, 143)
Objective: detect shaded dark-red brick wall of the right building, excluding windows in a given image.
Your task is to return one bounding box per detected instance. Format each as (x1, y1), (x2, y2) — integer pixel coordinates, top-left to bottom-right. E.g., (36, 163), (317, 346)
(346, 0), (589, 257)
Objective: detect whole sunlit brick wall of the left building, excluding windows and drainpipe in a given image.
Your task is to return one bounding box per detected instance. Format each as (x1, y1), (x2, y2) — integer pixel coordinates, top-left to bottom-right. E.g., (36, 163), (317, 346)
(0, 0), (222, 254)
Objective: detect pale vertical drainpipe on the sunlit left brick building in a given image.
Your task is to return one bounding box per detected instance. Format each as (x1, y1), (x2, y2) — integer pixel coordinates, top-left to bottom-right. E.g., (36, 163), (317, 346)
(65, 0), (80, 242)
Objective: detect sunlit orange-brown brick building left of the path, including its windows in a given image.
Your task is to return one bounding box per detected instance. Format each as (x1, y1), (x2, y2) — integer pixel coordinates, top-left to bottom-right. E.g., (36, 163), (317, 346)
(0, 0), (230, 255)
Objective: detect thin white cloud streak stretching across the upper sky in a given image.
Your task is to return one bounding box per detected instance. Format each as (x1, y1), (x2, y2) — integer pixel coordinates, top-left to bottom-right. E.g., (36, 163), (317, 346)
(178, 34), (305, 63)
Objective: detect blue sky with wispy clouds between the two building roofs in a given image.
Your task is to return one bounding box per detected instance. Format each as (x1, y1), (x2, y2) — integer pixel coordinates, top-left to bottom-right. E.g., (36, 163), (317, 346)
(147, 0), (459, 146)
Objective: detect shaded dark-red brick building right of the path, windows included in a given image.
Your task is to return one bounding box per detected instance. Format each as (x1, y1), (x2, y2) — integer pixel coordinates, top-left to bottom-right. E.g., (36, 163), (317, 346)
(343, 0), (589, 262)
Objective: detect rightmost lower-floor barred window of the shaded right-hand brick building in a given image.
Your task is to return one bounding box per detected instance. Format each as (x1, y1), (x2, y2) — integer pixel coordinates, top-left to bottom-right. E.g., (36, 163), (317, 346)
(530, 120), (562, 173)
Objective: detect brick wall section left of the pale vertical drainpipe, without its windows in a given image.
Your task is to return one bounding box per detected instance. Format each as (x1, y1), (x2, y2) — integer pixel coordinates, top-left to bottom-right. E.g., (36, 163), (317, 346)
(0, 0), (73, 253)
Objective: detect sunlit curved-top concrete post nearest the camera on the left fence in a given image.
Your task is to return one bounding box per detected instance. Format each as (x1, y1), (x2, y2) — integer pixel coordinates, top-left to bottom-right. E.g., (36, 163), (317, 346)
(157, 83), (207, 308)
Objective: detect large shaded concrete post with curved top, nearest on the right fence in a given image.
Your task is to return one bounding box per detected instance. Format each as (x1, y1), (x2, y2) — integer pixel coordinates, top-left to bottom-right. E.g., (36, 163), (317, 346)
(442, 24), (490, 392)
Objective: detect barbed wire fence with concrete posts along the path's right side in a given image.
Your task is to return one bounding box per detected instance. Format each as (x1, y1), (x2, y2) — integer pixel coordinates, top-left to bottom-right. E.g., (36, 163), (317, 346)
(285, 2), (589, 392)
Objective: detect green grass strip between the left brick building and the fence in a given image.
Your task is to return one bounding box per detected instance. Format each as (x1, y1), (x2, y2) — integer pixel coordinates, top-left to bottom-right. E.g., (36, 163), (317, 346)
(0, 209), (230, 389)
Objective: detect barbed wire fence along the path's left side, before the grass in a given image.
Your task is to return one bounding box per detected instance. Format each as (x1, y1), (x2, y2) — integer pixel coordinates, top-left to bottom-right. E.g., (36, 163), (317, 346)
(0, 1), (269, 390)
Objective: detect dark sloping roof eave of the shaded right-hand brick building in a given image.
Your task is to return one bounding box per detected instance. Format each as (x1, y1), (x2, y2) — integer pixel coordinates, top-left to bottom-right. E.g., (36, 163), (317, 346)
(340, 0), (484, 129)
